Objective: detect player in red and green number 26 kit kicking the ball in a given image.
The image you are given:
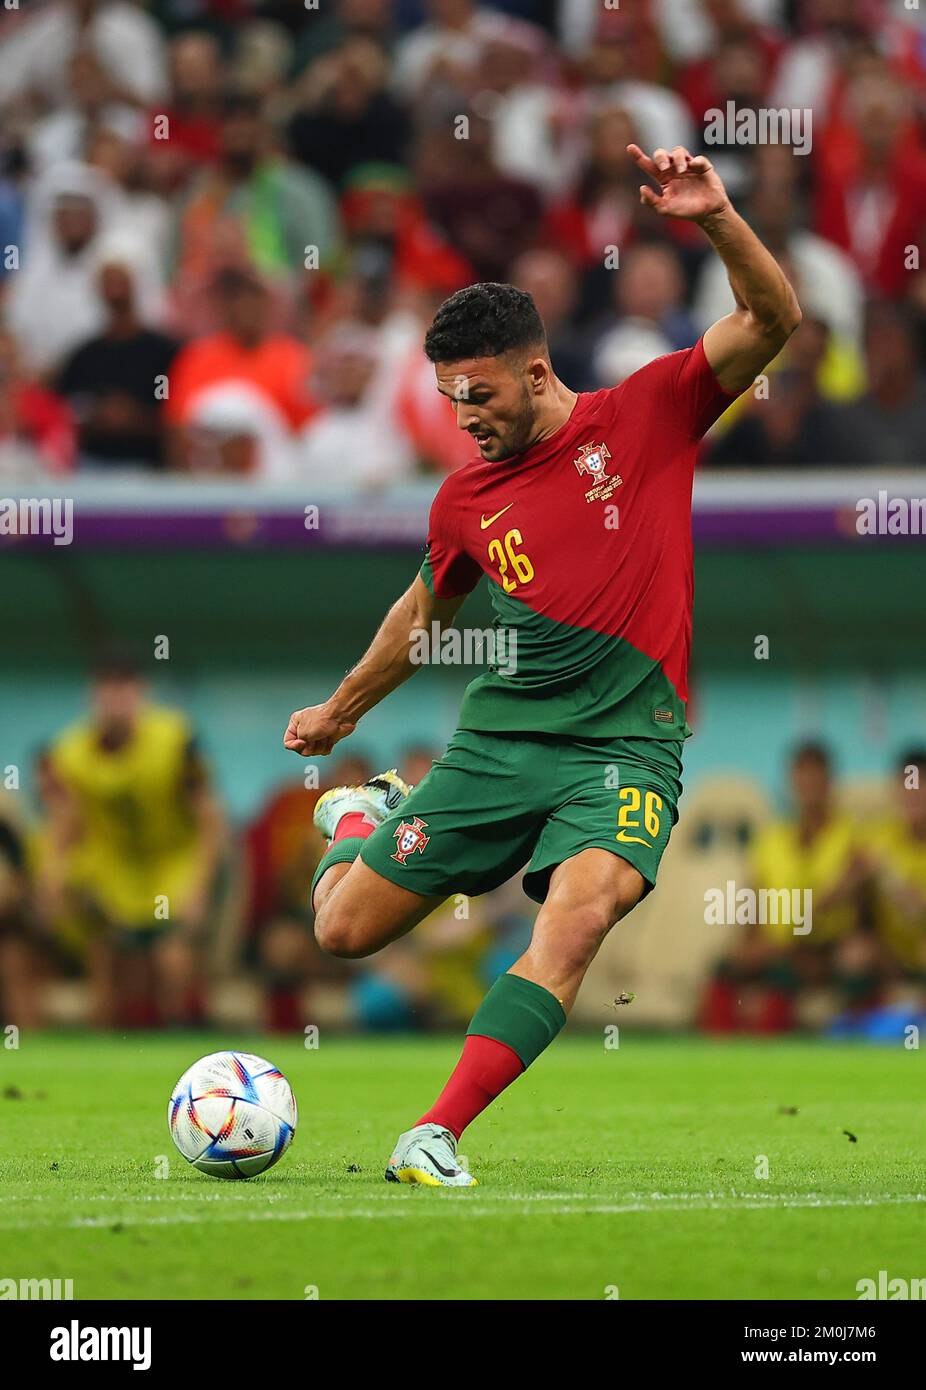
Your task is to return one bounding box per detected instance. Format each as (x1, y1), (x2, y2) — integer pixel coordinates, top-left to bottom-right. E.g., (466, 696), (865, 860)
(284, 145), (801, 1187)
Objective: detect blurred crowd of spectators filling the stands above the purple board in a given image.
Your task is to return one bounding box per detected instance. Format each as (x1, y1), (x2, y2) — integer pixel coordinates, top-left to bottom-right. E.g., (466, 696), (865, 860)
(0, 0), (926, 489)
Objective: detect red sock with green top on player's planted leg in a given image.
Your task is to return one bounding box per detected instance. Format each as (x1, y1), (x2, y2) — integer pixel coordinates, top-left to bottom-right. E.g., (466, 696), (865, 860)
(417, 974), (566, 1138)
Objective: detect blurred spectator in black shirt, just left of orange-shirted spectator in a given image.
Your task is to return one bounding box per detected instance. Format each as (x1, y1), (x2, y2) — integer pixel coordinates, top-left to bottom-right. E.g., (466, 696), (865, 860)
(56, 257), (178, 468)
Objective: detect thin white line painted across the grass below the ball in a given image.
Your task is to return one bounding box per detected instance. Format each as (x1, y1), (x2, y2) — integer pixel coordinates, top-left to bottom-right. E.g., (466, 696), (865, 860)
(0, 1193), (926, 1230)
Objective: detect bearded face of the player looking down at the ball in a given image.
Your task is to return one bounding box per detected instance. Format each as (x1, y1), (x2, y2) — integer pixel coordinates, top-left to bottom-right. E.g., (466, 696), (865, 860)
(435, 356), (549, 463)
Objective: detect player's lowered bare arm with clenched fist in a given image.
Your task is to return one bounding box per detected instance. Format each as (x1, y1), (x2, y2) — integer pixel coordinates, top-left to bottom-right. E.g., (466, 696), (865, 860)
(284, 575), (466, 758)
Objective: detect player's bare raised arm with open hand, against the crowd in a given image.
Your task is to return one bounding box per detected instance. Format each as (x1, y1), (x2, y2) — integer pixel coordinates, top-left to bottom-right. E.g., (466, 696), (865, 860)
(627, 145), (801, 392)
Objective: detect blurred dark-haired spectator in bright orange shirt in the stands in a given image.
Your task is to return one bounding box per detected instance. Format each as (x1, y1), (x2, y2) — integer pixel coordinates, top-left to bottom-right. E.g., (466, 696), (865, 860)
(164, 270), (317, 480)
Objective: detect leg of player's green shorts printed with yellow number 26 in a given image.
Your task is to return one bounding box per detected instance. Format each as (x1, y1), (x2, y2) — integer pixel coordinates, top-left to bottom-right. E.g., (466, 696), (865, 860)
(524, 738), (681, 920)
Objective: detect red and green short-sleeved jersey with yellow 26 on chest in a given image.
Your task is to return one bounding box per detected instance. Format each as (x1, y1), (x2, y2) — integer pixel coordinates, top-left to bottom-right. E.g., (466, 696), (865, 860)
(421, 341), (734, 739)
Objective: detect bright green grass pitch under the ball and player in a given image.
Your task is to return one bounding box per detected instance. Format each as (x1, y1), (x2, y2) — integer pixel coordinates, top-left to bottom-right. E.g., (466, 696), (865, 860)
(0, 1031), (926, 1300)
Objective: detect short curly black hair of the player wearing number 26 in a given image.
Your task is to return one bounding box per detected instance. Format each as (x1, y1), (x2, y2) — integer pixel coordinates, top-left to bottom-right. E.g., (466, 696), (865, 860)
(424, 281), (546, 361)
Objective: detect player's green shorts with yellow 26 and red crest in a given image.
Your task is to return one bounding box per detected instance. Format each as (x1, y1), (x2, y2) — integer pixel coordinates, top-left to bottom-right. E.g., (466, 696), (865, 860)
(360, 728), (681, 902)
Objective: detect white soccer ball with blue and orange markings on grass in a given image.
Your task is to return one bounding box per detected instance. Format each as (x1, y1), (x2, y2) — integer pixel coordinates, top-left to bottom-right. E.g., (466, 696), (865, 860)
(167, 1052), (296, 1177)
